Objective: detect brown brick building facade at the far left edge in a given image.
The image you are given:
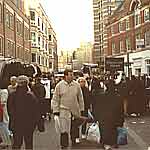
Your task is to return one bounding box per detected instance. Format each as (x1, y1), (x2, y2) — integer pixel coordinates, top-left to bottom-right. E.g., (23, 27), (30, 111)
(0, 0), (31, 63)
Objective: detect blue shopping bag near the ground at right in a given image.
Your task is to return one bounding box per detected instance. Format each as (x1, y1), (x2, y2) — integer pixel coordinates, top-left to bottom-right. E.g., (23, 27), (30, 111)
(117, 127), (128, 145)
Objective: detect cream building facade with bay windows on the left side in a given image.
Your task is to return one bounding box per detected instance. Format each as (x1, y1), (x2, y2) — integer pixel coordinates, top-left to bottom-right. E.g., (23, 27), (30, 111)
(30, 3), (58, 72)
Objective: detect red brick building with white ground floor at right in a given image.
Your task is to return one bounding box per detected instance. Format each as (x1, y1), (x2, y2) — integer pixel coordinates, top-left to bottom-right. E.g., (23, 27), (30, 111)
(106, 0), (150, 75)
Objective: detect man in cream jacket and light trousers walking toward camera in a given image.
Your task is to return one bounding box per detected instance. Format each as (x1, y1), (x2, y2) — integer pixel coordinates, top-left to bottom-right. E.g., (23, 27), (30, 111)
(51, 69), (84, 148)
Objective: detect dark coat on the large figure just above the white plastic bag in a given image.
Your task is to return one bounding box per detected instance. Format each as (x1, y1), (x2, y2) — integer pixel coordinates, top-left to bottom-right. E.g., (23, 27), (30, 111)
(92, 89), (124, 126)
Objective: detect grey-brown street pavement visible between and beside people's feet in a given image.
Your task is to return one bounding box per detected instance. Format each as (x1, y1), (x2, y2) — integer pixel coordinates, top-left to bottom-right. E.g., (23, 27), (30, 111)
(34, 116), (150, 150)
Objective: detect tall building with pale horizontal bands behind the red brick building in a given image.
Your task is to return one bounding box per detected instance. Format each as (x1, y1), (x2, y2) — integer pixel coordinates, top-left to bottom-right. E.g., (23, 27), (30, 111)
(93, 0), (124, 70)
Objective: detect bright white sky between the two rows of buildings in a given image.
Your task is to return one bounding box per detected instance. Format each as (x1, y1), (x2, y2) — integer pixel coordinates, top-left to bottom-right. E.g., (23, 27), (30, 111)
(42, 0), (93, 49)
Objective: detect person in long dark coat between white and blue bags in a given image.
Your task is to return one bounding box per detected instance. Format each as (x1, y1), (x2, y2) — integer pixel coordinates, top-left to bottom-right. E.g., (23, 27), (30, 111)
(93, 81), (124, 149)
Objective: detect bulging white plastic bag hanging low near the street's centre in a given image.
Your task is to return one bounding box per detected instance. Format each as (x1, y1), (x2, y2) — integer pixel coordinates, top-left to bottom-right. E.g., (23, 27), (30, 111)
(86, 122), (100, 143)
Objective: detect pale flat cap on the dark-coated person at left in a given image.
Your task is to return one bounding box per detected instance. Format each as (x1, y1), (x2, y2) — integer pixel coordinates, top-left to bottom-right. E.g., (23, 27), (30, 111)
(17, 75), (29, 86)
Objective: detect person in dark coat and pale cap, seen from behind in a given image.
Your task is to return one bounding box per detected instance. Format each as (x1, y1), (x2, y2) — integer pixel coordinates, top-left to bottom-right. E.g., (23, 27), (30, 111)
(8, 75), (39, 149)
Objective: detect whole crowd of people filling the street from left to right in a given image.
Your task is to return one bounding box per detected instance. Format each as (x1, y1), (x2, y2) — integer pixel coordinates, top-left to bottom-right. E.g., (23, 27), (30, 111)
(0, 69), (149, 150)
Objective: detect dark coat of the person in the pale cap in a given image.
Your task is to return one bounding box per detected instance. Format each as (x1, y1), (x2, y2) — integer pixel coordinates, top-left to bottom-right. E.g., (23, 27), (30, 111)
(7, 88), (39, 135)
